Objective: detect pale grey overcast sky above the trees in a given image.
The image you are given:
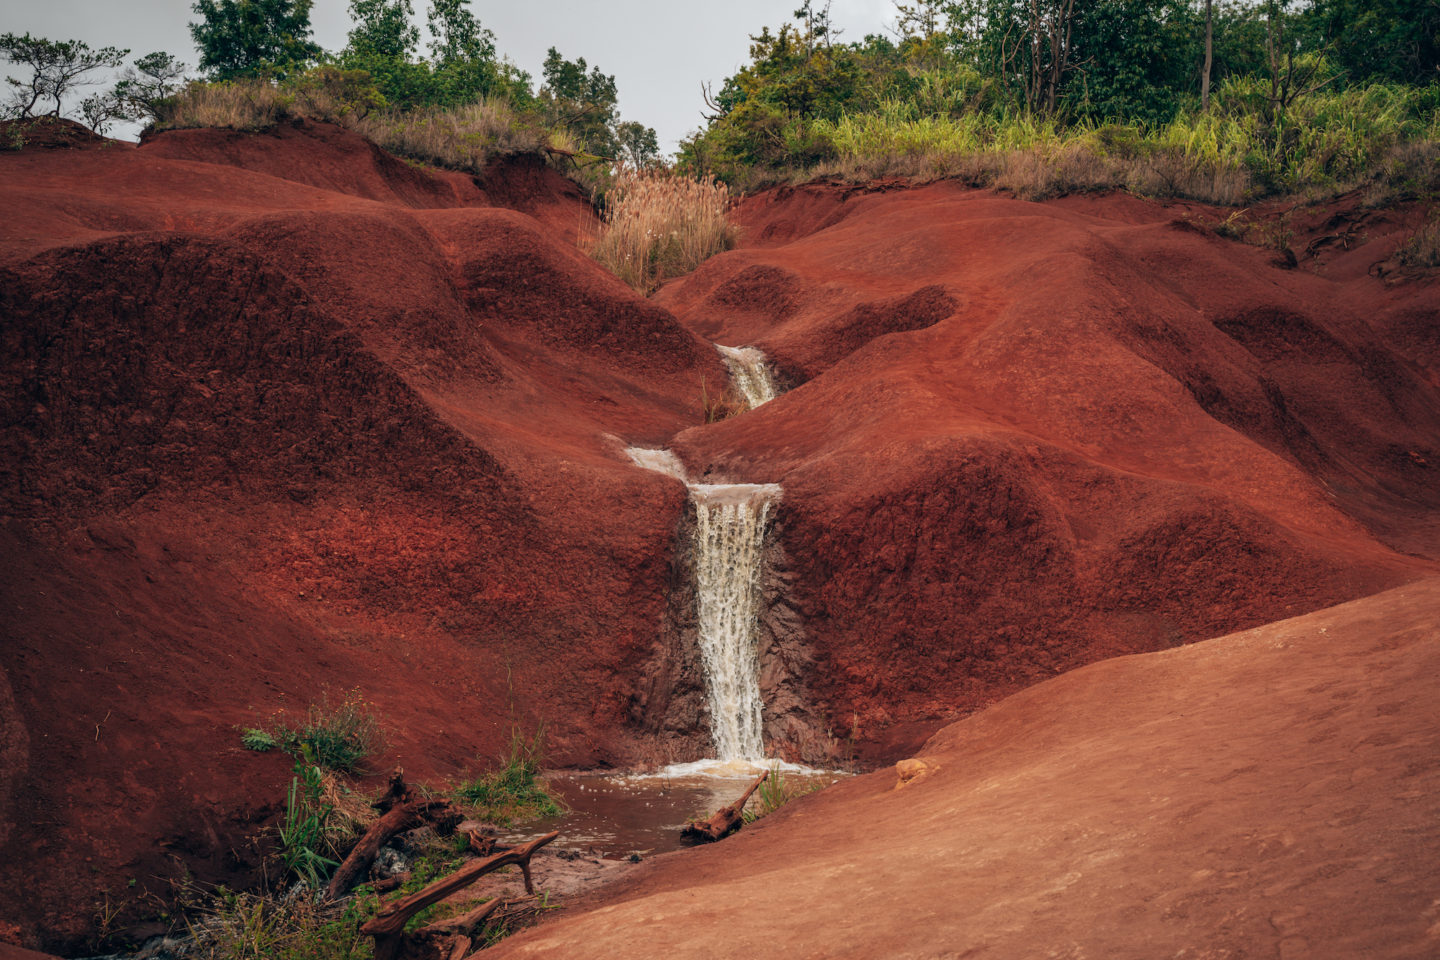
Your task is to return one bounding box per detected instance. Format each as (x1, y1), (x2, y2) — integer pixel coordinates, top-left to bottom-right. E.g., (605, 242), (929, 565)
(0, 0), (894, 153)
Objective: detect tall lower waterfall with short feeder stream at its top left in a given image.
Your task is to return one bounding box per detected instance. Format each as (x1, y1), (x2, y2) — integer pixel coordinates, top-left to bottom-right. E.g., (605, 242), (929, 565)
(626, 448), (780, 761)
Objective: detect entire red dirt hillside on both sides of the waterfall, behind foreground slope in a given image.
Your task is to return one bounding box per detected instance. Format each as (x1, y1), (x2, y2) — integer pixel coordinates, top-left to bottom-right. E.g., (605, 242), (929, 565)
(0, 124), (1440, 951)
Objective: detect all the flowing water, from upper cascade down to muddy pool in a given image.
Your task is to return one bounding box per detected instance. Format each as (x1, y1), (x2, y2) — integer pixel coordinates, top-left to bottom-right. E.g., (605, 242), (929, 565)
(506, 344), (841, 856)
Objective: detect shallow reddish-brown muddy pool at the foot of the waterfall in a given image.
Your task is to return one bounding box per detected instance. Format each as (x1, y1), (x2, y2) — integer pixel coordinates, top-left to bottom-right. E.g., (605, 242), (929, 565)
(503, 764), (844, 856)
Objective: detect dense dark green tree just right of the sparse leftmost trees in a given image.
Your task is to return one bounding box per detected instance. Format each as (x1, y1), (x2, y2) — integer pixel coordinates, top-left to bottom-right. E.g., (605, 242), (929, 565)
(190, 0), (321, 81)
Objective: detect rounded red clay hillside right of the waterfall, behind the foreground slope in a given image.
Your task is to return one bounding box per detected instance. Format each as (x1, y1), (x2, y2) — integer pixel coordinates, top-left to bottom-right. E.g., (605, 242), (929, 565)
(657, 178), (1440, 744)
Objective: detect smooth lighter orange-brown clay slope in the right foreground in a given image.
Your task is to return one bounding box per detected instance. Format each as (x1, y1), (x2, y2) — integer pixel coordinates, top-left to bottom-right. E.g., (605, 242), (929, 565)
(494, 580), (1440, 960)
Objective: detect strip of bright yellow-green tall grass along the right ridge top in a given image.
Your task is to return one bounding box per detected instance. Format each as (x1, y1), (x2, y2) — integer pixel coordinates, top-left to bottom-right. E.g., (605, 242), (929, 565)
(812, 78), (1440, 203)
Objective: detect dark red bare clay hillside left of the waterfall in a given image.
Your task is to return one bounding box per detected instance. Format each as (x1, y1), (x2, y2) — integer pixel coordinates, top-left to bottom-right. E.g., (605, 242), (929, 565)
(0, 125), (724, 950)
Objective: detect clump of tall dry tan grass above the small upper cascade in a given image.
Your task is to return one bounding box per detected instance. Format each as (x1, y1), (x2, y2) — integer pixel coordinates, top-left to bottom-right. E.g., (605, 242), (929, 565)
(585, 170), (737, 294)
